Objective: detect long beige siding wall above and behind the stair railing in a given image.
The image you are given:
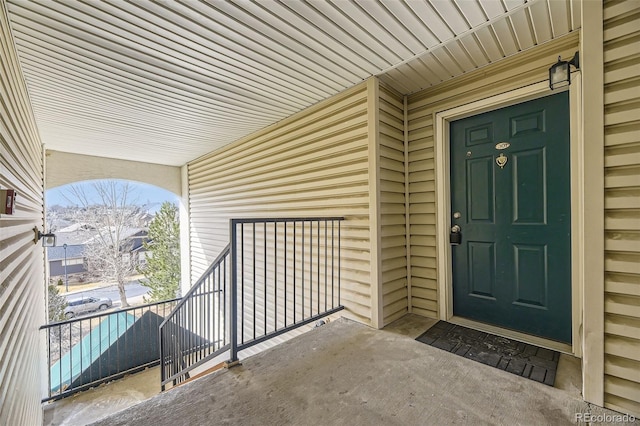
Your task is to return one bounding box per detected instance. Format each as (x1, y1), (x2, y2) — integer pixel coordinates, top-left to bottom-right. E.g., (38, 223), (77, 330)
(188, 83), (372, 324)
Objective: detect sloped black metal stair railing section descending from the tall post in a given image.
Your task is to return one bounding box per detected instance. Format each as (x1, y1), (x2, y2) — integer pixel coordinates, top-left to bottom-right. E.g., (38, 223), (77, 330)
(159, 245), (230, 390)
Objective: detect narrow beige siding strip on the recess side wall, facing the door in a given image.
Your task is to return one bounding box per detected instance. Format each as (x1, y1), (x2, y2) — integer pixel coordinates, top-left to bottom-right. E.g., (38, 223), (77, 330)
(378, 84), (408, 324)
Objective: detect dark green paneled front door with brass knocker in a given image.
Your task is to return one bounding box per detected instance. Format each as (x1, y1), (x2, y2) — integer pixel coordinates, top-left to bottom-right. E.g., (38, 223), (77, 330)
(450, 92), (571, 342)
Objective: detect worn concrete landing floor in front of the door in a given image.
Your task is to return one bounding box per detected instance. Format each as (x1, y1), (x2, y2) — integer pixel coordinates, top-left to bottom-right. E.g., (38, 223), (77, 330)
(74, 315), (632, 426)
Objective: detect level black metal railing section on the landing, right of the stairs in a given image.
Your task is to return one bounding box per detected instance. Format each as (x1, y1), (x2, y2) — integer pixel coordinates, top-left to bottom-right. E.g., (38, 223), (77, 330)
(230, 217), (344, 362)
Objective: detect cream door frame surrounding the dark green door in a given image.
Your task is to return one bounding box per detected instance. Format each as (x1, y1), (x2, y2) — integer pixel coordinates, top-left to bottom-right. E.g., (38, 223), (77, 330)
(434, 79), (585, 357)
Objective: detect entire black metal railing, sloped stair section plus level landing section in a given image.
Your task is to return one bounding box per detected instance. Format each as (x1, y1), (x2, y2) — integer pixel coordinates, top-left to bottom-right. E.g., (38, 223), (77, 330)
(160, 217), (344, 390)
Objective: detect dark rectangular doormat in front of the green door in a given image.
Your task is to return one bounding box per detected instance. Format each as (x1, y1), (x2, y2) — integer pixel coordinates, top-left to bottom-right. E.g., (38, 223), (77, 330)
(416, 321), (560, 386)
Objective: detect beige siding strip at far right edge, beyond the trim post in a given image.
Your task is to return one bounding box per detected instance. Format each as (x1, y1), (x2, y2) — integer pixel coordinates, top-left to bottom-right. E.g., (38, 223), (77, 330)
(604, 1), (640, 415)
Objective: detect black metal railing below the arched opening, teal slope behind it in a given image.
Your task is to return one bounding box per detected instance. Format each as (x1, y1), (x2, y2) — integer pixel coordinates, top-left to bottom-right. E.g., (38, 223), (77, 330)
(40, 299), (180, 402)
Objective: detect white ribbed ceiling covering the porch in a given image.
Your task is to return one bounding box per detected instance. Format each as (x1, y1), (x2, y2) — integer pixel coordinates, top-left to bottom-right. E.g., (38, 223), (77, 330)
(6, 0), (580, 166)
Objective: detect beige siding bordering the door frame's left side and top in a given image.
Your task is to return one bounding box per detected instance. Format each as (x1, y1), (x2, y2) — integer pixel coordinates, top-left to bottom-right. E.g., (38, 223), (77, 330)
(407, 33), (578, 318)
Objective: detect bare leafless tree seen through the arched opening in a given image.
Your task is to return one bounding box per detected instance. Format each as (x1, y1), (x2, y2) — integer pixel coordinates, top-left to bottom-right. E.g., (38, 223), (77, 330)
(64, 180), (140, 308)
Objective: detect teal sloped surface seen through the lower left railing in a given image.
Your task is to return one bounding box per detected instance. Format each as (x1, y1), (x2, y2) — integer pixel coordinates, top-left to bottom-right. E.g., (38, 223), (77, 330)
(50, 312), (136, 392)
